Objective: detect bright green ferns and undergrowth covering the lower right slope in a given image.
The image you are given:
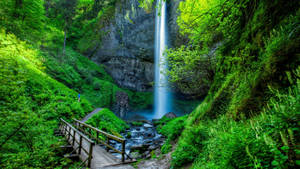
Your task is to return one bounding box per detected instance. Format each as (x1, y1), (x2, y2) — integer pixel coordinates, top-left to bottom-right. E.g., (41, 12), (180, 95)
(172, 68), (300, 168)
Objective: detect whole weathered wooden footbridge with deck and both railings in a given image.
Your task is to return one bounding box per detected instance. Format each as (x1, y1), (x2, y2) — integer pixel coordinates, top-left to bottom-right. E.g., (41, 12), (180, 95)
(59, 119), (134, 169)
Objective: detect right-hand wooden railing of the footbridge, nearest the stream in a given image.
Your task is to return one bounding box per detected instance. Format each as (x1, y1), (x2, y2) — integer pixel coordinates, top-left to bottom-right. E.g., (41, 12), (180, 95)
(74, 119), (132, 162)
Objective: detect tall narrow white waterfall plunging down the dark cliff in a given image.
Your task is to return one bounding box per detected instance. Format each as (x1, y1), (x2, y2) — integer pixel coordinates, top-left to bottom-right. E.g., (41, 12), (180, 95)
(154, 0), (172, 118)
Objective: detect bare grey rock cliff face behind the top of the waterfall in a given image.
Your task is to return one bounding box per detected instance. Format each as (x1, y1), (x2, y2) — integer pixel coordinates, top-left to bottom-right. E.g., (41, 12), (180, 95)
(90, 0), (180, 91)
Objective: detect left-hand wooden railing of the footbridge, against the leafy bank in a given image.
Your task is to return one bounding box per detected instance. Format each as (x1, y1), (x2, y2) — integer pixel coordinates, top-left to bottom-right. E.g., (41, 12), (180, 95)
(60, 118), (95, 167)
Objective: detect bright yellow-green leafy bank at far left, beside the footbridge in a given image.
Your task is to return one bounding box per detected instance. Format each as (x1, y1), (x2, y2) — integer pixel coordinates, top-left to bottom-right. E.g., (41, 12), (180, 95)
(0, 30), (92, 168)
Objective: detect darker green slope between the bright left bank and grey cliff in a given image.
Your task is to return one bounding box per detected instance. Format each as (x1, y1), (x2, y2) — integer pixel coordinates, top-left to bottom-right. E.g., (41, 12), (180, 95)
(45, 48), (121, 107)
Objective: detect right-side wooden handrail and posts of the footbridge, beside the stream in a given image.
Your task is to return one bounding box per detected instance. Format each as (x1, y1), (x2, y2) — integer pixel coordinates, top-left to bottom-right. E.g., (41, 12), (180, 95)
(73, 119), (131, 162)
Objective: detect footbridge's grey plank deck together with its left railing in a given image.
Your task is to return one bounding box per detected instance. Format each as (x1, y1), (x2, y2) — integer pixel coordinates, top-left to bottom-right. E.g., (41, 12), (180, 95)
(61, 120), (134, 169)
